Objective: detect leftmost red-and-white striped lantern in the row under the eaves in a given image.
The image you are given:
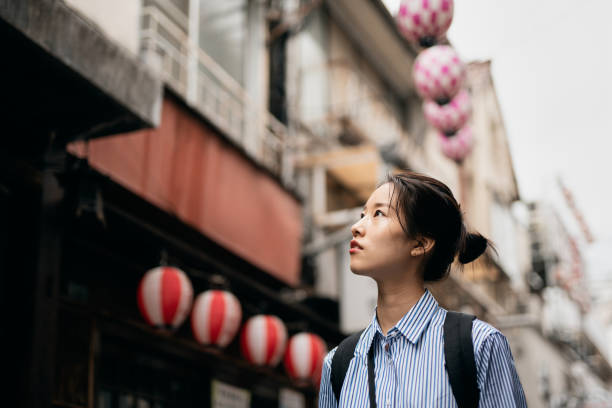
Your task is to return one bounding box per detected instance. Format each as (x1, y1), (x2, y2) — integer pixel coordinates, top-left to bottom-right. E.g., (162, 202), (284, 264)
(138, 266), (193, 329)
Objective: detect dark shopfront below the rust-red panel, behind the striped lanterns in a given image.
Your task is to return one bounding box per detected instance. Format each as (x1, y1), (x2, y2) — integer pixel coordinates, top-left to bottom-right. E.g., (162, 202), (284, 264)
(54, 167), (341, 407)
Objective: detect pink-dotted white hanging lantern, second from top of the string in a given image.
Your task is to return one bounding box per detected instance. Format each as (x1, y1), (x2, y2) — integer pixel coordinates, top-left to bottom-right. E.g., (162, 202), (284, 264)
(412, 45), (465, 105)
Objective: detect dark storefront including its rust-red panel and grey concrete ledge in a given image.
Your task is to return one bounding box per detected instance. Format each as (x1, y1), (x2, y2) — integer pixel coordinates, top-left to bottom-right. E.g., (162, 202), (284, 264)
(0, 0), (342, 408)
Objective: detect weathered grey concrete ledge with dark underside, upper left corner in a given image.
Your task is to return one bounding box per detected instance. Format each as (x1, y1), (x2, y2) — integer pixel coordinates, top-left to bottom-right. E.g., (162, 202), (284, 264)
(0, 0), (162, 132)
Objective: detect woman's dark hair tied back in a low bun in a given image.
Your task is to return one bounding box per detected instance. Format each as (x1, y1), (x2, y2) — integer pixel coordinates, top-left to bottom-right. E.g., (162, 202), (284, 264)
(383, 171), (491, 282)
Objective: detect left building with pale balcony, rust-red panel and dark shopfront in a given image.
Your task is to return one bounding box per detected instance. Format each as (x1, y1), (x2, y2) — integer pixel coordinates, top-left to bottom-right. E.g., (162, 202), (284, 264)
(0, 0), (342, 407)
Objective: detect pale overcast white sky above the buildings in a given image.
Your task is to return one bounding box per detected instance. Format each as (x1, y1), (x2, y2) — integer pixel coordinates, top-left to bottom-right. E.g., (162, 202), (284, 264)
(384, 0), (612, 245)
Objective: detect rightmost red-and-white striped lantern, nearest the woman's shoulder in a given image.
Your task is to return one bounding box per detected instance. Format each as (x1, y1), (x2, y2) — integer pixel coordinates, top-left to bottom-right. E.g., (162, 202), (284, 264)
(284, 333), (327, 383)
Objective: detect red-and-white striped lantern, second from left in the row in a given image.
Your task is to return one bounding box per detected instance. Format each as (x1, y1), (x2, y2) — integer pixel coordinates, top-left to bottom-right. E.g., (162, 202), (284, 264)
(191, 290), (242, 347)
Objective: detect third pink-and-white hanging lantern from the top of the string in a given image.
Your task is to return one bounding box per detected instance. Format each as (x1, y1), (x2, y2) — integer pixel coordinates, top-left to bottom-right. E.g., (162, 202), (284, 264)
(423, 89), (472, 136)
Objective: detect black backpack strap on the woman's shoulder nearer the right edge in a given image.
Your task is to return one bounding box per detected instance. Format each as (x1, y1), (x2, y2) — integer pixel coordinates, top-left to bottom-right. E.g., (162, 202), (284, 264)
(444, 311), (480, 408)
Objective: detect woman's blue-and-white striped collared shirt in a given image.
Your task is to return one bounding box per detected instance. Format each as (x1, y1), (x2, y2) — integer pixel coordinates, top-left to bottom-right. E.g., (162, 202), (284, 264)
(319, 290), (527, 408)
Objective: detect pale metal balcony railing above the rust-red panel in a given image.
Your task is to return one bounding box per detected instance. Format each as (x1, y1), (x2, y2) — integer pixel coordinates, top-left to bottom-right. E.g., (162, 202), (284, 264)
(141, 0), (291, 182)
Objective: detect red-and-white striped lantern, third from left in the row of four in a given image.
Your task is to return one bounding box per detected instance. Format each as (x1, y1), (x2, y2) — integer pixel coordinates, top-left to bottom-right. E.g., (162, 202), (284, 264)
(240, 315), (287, 366)
